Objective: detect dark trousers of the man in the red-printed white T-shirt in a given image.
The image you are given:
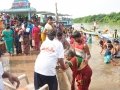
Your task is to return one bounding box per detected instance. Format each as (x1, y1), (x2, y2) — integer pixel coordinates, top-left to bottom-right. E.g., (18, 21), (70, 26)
(34, 72), (58, 90)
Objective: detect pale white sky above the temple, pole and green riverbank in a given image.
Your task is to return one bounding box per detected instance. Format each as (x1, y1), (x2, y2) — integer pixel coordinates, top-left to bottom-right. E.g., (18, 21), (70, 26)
(0, 0), (120, 17)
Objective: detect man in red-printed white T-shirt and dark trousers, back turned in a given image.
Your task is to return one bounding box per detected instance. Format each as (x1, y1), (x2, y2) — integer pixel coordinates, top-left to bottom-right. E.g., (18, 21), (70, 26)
(34, 30), (66, 90)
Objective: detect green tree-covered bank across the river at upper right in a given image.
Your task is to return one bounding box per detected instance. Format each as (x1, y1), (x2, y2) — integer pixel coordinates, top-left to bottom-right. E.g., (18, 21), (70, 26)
(73, 12), (120, 24)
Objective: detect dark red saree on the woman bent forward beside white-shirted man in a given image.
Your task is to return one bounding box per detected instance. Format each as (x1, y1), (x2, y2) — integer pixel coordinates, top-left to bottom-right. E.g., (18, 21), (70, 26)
(70, 57), (92, 90)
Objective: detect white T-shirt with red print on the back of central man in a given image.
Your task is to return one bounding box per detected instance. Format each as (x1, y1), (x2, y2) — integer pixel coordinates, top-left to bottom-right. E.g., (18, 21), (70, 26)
(35, 38), (64, 76)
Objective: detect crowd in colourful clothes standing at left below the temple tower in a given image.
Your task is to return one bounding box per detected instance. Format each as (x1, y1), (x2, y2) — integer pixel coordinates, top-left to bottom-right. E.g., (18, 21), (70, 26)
(0, 13), (47, 56)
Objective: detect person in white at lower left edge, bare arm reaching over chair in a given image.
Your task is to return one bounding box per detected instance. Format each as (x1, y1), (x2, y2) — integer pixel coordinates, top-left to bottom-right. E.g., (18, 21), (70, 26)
(0, 55), (20, 90)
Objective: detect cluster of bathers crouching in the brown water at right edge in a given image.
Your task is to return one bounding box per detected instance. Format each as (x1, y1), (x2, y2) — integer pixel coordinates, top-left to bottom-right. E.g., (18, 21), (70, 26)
(99, 38), (120, 65)
